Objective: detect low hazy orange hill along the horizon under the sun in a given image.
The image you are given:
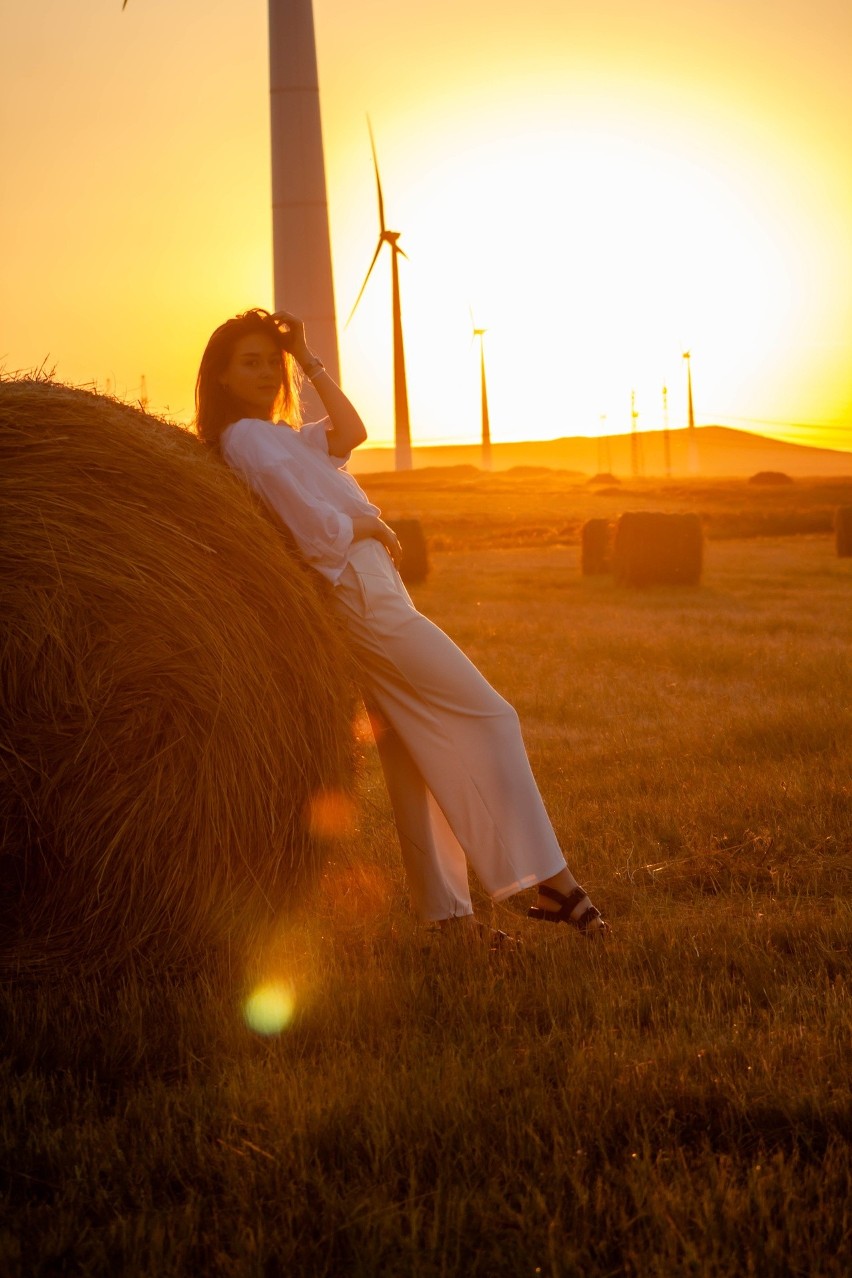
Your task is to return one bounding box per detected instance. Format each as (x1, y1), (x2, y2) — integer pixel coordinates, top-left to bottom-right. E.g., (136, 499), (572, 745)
(349, 426), (852, 478)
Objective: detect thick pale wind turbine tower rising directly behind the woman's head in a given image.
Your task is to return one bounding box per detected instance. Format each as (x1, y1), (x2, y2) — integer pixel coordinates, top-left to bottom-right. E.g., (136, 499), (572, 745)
(270, 0), (340, 381)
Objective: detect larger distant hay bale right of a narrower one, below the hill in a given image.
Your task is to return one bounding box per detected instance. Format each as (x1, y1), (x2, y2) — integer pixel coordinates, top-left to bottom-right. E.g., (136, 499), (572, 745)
(613, 511), (704, 585)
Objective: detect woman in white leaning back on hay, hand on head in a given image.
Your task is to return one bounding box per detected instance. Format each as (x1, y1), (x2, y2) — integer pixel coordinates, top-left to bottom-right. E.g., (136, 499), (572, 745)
(195, 309), (608, 937)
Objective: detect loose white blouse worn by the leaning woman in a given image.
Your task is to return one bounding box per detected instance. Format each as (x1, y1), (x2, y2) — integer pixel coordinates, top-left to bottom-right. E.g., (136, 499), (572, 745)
(220, 418), (379, 585)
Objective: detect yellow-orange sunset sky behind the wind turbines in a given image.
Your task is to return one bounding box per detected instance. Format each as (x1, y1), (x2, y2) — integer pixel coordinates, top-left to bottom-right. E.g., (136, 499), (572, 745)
(0, 0), (852, 449)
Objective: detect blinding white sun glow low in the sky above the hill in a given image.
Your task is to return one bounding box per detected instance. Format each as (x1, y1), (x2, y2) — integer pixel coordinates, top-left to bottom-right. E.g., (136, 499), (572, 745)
(342, 88), (843, 442)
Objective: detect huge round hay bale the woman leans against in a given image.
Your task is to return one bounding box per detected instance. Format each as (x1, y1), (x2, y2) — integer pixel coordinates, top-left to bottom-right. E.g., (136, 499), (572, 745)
(0, 380), (351, 975)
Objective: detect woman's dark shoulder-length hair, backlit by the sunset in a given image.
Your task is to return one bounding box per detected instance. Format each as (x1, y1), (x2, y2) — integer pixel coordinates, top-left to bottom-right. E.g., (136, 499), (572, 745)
(195, 307), (300, 450)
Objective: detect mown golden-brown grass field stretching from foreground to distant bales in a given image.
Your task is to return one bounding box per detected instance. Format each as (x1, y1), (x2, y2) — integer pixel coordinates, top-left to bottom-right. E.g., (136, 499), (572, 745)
(0, 516), (852, 1278)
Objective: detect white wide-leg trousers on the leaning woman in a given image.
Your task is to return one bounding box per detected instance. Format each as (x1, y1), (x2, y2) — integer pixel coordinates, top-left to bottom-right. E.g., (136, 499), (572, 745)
(335, 538), (565, 920)
